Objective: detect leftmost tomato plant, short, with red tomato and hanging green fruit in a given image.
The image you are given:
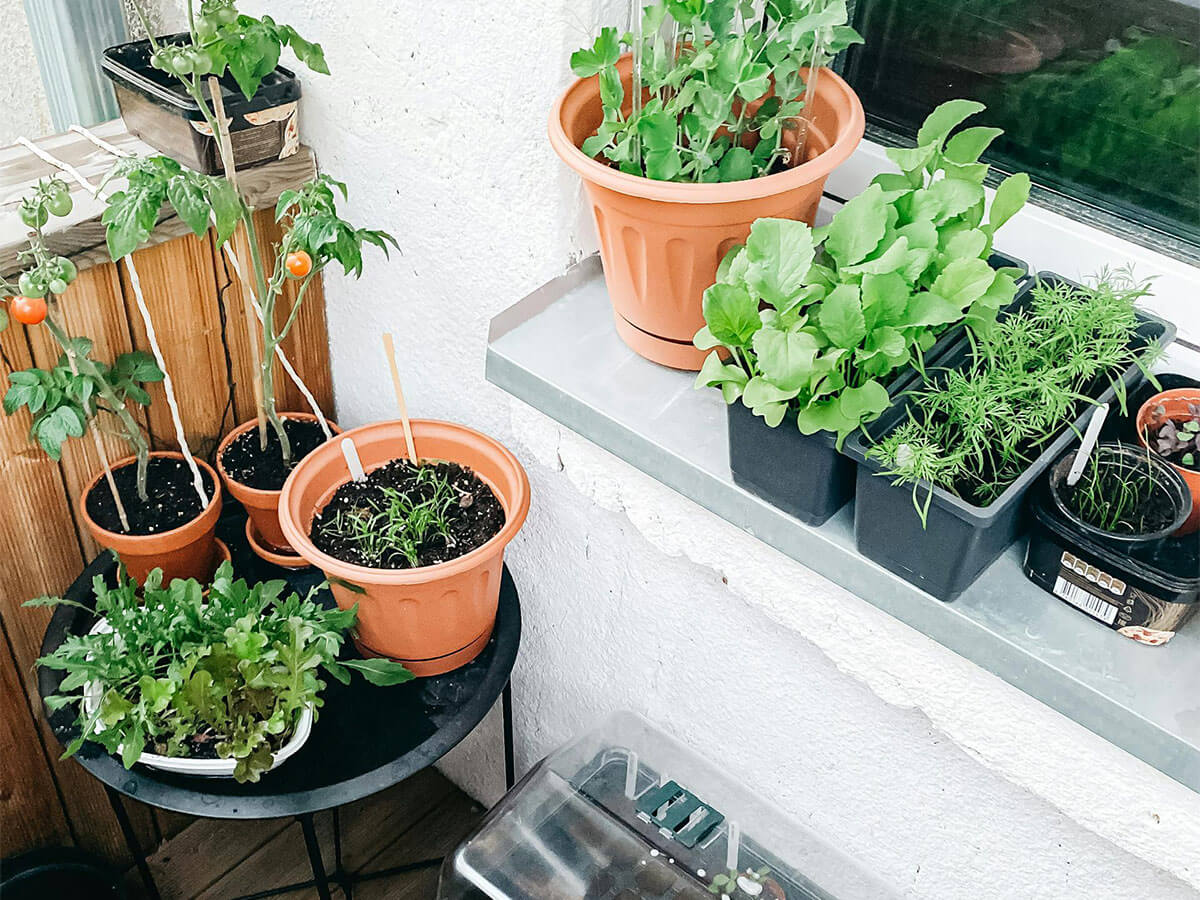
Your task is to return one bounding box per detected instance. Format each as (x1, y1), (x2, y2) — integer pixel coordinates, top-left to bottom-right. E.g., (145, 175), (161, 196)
(0, 179), (164, 511)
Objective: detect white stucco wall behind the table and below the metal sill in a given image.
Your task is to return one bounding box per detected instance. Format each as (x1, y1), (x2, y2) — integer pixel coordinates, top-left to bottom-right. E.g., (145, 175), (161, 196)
(164, 0), (1200, 900)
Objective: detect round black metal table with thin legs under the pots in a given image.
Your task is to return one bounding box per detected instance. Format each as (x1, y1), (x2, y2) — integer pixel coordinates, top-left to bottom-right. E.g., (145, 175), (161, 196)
(38, 516), (521, 900)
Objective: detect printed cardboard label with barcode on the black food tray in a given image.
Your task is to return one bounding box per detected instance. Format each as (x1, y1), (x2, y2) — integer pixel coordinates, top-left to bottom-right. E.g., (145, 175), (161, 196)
(1054, 552), (1192, 646)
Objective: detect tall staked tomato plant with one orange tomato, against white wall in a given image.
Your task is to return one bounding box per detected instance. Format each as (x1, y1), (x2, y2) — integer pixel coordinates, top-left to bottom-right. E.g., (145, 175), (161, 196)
(103, 0), (397, 466)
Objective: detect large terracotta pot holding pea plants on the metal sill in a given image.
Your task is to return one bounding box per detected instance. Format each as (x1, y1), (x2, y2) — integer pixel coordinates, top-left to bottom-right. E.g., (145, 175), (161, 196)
(550, 54), (865, 370)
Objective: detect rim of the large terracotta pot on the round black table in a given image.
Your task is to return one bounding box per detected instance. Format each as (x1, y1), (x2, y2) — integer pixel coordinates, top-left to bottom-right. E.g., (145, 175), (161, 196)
(280, 419), (529, 584)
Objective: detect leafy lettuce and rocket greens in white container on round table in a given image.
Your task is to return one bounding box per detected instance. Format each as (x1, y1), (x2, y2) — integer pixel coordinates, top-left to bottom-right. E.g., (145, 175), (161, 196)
(25, 563), (413, 781)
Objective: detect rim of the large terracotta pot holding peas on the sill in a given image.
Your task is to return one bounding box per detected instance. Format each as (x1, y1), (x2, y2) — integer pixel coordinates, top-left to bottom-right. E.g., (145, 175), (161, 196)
(548, 59), (866, 203)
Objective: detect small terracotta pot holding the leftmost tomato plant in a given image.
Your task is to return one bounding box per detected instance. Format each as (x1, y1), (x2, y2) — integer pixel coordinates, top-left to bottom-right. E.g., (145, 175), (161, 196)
(79, 450), (222, 584)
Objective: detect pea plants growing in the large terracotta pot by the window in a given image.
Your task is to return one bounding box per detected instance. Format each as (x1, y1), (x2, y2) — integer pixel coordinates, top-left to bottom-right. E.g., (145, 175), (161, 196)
(571, 0), (862, 182)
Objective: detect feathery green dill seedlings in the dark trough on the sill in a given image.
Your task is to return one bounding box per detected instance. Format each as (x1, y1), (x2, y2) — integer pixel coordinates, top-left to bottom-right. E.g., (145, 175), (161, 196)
(866, 269), (1160, 523)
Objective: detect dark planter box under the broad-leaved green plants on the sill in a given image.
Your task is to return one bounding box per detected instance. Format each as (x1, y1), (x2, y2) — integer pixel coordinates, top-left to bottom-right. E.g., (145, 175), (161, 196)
(728, 401), (854, 526)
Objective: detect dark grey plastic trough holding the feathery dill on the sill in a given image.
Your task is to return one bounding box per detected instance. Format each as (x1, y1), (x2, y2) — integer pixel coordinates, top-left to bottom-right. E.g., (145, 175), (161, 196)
(846, 272), (1175, 600)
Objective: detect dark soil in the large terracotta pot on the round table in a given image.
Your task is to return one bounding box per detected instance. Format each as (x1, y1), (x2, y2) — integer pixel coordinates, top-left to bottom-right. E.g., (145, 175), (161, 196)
(310, 460), (505, 569)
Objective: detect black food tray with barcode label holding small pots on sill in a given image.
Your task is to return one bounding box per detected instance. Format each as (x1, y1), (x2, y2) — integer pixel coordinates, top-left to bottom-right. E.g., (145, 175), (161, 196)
(1022, 449), (1200, 646)
